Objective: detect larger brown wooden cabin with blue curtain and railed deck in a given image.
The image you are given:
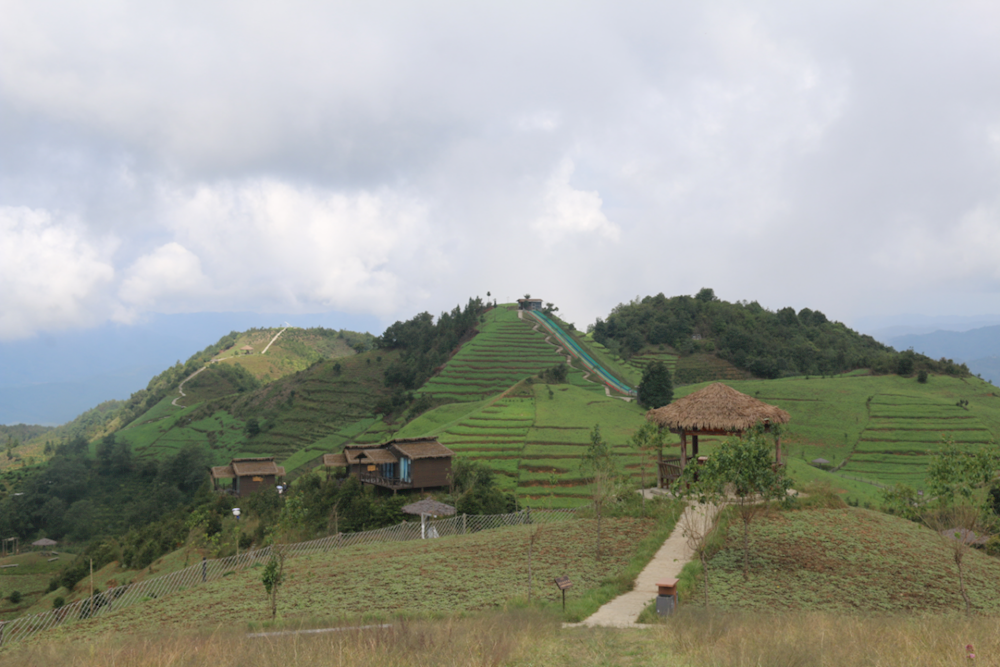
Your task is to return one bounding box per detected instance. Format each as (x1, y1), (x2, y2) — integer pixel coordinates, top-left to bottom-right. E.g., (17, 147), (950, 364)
(323, 438), (455, 491)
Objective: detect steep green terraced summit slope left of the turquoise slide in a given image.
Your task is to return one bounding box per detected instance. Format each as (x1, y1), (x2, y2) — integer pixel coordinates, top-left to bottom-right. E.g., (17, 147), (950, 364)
(418, 305), (603, 401)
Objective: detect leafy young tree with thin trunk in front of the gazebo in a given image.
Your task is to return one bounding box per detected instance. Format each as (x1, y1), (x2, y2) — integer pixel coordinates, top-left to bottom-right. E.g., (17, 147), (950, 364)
(678, 424), (792, 580)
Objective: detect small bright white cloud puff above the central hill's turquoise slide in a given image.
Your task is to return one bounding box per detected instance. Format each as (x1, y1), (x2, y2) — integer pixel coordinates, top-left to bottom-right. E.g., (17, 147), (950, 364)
(532, 160), (621, 245)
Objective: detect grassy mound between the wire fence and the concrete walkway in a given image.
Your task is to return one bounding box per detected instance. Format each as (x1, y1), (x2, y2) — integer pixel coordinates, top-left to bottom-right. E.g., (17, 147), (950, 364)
(37, 507), (677, 637)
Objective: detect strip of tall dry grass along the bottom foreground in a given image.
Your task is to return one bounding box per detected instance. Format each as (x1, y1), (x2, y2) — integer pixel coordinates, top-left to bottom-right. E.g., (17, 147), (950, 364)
(7, 608), (1000, 667)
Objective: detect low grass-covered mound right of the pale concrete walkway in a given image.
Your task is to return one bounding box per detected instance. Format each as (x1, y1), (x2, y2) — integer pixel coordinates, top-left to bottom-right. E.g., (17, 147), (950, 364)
(685, 508), (1000, 614)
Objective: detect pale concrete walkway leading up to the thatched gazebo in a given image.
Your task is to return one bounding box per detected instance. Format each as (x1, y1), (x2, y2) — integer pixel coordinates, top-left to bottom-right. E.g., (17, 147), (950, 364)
(563, 505), (718, 628)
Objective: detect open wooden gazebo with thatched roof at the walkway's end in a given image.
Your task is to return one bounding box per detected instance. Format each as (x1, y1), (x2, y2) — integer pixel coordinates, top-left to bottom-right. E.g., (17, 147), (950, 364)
(646, 382), (791, 487)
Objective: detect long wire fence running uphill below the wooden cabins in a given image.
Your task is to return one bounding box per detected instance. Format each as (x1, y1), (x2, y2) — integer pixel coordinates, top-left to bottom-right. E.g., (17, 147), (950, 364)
(0, 508), (577, 646)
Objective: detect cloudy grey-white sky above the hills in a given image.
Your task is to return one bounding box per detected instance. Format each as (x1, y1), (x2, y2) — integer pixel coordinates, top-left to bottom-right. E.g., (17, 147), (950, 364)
(0, 0), (1000, 344)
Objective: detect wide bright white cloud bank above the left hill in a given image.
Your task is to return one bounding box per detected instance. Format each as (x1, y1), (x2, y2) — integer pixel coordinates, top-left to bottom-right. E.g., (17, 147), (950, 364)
(158, 179), (432, 315)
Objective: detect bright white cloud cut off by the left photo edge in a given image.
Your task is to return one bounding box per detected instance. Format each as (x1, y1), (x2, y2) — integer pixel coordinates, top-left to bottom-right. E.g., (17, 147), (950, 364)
(0, 206), (115, 340)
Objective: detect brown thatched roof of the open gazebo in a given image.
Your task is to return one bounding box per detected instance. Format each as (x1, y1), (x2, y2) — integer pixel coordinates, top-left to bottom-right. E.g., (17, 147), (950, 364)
(646, 382), (791, 432)
